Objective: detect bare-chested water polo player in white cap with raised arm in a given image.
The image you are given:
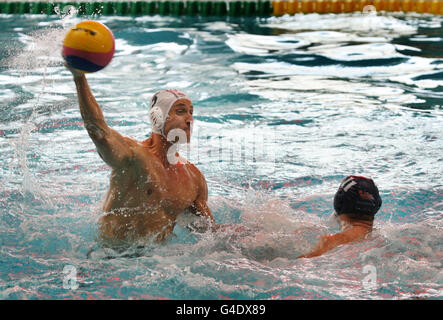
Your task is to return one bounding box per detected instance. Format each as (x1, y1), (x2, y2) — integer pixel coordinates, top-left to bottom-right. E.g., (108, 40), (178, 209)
(68, 67), (220, 242)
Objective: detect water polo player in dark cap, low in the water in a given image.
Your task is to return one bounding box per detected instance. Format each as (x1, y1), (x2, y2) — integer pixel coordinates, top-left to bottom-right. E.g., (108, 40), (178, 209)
(299, 176), (382, 258)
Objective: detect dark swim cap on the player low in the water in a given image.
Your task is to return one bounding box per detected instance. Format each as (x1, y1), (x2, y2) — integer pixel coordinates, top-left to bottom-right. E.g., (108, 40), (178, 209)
(334, 176), (382, 220)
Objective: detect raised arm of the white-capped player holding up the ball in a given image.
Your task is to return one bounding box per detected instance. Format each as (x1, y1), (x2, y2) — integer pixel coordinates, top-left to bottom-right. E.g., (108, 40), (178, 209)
(68, 68), (136, 168)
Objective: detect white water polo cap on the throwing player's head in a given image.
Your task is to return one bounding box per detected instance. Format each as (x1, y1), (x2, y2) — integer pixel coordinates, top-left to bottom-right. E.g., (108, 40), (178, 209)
(149, 89), (191, 138)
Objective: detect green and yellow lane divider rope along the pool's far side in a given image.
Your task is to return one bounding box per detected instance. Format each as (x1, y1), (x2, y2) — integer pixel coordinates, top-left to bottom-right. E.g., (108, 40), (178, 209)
(0, 0), (443, 17)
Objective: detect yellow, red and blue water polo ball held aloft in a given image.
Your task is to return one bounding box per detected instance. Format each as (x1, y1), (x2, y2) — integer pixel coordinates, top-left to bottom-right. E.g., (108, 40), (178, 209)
(62, 21), (115, 73)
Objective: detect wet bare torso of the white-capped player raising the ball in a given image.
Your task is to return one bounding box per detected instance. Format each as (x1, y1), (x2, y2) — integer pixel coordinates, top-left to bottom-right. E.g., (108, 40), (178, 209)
(99, 141), (200, 241)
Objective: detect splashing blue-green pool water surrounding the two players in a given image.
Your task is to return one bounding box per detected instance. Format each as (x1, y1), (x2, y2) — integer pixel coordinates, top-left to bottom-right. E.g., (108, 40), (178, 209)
(0, 13), (443, 299)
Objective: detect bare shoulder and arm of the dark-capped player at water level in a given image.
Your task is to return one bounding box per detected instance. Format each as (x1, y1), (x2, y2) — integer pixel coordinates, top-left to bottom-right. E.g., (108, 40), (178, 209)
(298, 228), (366, 258)
